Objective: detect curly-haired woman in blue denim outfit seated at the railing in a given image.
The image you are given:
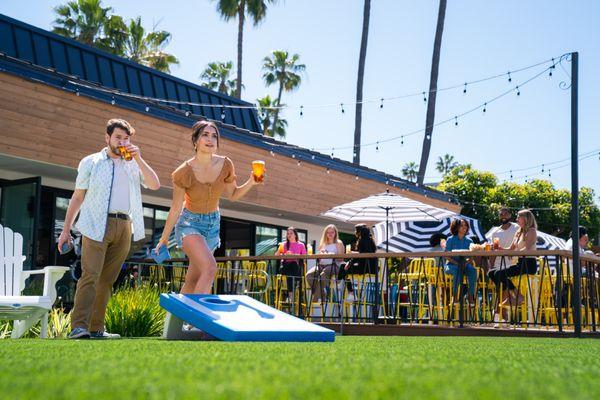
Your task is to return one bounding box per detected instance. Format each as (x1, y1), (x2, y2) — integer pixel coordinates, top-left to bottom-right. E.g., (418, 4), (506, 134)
(444, 218), (477, 304)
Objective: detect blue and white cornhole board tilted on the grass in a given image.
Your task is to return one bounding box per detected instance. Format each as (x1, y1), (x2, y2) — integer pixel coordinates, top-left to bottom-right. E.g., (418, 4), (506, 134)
(160, 293), (335, 342)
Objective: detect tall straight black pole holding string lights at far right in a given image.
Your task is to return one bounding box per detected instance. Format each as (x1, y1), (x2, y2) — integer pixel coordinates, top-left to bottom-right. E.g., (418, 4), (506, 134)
(571, 52), (581, 338)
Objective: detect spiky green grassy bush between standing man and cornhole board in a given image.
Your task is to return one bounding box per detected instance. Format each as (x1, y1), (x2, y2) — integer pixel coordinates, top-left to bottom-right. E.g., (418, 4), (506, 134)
(105, 287), (165, 337)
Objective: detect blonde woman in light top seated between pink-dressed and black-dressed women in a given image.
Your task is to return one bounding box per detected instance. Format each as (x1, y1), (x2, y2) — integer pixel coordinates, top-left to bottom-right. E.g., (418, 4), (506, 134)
(306, 224), (346, 302)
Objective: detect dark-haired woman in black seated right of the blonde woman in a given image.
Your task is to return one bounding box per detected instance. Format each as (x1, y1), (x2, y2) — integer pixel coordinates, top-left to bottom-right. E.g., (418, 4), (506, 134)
(338, 224), (377, 301)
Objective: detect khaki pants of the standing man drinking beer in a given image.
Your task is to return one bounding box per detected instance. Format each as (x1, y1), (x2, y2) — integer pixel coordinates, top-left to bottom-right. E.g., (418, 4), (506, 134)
(71, 218), (131, 332)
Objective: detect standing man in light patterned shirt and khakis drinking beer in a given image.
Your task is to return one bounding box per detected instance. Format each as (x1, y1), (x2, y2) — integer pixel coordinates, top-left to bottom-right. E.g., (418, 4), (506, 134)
(58, 119), (160, 339)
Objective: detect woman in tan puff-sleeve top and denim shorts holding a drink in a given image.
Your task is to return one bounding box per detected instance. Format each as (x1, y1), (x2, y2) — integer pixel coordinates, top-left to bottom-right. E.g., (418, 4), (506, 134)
(154, 121), (260, 294)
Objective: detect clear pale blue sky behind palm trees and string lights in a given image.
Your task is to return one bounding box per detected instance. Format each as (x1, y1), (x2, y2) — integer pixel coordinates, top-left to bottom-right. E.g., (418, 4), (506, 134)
(0, 0), (600, 200)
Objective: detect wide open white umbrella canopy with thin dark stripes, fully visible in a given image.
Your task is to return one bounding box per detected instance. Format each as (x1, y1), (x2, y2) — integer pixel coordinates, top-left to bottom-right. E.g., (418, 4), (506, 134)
(321, 192), (456, 222)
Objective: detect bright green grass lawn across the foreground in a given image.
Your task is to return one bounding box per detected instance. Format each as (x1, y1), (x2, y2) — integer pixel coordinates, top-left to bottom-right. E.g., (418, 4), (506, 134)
(0, 337), (600, 399)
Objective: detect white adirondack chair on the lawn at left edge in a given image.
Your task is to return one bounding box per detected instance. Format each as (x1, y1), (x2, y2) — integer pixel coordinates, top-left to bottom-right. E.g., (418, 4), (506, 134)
(0, 225), (69, 339)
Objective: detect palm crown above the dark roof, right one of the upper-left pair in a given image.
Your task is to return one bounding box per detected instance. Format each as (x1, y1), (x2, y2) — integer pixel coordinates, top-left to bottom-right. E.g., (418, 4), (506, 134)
(125, 17), (179, 73)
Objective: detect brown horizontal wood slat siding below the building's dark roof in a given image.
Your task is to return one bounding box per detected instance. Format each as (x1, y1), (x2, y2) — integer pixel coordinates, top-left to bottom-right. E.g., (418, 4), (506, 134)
(0, 73), (460, 216)
